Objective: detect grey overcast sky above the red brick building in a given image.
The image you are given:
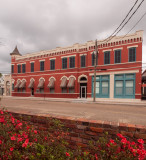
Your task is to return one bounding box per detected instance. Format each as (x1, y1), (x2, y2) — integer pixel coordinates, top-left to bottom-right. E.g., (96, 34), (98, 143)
(0, 0), (146, 73)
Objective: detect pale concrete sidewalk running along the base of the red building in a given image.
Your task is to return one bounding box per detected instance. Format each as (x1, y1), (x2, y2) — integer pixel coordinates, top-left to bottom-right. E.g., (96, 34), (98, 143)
(1, 96), (146, 107)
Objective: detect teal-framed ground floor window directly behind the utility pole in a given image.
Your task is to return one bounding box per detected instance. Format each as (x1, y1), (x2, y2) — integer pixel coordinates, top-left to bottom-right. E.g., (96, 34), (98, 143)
(92, 75), (109, 98)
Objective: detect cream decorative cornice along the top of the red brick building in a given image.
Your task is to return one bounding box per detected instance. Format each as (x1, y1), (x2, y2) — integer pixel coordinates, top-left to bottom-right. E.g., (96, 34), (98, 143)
(16, 30), (143, 60)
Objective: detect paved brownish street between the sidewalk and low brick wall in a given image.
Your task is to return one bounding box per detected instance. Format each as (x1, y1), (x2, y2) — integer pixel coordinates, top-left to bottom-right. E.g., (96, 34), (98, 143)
(1, 97), (146, 125)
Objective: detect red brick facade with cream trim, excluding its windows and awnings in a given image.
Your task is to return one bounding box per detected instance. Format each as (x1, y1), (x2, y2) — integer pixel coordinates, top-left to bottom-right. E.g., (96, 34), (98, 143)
(11, 31), (143, 99)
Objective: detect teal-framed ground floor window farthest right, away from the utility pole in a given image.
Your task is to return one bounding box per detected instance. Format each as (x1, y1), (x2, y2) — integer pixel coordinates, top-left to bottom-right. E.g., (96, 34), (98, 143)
(114, 74), (135, 98)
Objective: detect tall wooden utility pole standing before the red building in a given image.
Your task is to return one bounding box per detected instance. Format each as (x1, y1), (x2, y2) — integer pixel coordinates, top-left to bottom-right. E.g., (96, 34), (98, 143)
(93, 39), (98, 102)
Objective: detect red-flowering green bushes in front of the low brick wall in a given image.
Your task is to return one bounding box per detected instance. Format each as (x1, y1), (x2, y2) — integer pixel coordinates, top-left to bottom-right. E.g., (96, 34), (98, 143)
(0, 110), (146, 160)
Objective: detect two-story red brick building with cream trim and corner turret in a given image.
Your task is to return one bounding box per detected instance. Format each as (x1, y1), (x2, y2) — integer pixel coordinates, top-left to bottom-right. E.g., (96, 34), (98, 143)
(10, 31), (143, 99)
